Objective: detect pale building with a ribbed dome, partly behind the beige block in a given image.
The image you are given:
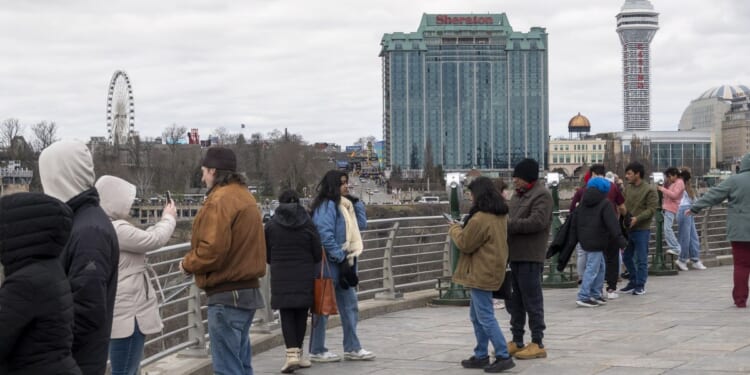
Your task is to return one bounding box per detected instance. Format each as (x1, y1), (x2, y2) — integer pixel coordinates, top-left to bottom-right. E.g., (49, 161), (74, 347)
(679, 85), (750, 161)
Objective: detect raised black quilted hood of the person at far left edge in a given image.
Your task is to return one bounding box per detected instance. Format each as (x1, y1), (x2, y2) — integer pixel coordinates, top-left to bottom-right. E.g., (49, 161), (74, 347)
(0, 193), (73, 276)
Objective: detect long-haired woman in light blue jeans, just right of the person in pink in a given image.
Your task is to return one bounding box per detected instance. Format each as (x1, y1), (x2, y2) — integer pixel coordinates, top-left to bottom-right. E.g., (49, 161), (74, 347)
(675, 167), (706, 271)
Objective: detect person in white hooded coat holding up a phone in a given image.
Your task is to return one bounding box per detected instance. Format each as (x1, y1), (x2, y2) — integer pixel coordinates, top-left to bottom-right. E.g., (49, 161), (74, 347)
(96, 176), (177, 375)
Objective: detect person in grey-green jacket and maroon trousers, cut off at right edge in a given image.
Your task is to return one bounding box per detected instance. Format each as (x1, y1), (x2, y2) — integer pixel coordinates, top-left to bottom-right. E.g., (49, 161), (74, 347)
(685, 154), (750, 308)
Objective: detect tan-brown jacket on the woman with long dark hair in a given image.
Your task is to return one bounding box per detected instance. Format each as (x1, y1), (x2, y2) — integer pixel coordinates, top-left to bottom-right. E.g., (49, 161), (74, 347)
(449, 212), (508, 291)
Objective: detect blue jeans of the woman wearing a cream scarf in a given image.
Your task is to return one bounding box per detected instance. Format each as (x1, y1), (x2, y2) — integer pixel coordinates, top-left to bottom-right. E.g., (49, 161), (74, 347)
(310, 278), (362, 354)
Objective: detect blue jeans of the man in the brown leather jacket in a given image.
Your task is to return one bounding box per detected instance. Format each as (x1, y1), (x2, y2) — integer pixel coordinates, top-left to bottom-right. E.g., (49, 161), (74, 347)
(208, 305), (255, 375)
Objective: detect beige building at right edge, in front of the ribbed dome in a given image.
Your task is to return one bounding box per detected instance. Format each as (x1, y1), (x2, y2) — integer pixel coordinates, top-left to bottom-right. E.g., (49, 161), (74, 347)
(717, 96), (750, 165)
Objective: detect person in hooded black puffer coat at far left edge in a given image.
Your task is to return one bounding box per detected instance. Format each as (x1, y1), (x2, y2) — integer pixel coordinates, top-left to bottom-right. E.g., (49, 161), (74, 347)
(0, 193), (81, 375)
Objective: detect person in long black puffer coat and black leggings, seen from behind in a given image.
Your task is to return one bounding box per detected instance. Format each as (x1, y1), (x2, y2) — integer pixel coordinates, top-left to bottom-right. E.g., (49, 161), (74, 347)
(266, 190), (322, 373)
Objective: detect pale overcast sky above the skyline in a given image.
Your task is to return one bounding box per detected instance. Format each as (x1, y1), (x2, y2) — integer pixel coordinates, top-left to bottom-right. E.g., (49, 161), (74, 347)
(0, 0), (750, 146)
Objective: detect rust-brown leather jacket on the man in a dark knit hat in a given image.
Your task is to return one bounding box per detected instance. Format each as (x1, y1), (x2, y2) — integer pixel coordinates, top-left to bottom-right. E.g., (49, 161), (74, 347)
(182, 184), (266, 295)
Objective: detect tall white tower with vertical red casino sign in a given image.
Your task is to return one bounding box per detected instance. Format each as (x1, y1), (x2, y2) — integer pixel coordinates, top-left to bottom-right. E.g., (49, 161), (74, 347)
(617, 0), (659, 131)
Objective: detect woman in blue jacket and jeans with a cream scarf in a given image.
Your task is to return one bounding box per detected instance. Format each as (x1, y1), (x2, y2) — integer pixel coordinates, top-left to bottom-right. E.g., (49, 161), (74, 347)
(310, 170), (375, 362)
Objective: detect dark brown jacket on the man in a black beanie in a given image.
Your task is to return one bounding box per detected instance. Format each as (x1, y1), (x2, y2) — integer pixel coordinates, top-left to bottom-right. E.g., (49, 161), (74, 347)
(508, 180), (552, 263)
